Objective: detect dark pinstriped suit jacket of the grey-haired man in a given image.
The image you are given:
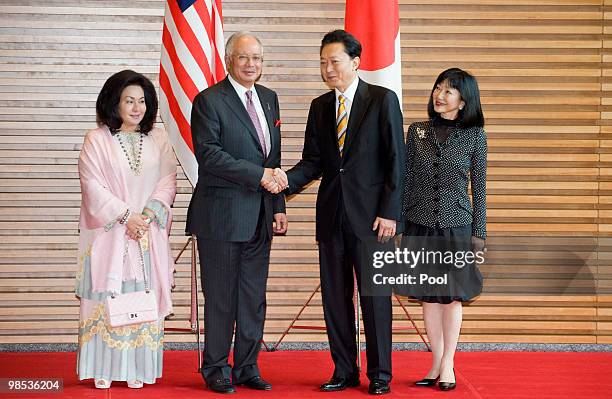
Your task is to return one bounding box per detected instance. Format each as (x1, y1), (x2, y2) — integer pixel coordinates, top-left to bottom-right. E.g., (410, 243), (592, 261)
(186, 78), (285, 242)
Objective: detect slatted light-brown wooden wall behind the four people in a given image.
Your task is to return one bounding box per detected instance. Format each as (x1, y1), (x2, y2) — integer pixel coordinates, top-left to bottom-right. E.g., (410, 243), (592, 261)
(0, 0), (612, 343)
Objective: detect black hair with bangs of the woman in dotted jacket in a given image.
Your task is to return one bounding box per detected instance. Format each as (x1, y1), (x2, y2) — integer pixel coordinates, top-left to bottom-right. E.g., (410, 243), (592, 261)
(427, 68), (484, 127)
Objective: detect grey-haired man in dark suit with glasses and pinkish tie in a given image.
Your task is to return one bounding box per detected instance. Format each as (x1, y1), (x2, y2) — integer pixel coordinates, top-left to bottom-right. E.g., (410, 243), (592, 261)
(186, 32), (287, 393)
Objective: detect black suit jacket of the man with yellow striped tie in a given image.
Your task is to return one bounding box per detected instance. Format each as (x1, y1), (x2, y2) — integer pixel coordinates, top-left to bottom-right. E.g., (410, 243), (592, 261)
(287, 80), (404, 241)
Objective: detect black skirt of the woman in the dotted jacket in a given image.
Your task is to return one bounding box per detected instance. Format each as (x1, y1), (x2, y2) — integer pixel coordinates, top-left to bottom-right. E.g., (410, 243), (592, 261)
(399, 222), (482, 304)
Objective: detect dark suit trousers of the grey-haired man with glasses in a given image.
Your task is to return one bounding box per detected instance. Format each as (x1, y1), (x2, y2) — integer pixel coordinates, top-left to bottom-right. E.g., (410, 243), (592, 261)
(198, 202), (272, 384)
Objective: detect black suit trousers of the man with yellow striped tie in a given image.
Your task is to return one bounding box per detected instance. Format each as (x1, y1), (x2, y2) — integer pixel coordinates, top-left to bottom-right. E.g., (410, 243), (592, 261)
(319, 201), (392, 381)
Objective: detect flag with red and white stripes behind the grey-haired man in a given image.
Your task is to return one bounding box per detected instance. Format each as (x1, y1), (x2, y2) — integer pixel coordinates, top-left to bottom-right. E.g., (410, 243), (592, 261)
(159, 0), (225, 186)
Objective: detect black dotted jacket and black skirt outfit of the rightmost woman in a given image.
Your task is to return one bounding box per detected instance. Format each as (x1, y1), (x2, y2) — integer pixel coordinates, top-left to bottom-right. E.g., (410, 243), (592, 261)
(402, 118), (487, 303)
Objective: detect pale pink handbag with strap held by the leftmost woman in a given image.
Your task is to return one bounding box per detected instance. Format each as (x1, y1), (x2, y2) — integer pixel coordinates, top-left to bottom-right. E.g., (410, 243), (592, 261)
(105, 241), (159, 327)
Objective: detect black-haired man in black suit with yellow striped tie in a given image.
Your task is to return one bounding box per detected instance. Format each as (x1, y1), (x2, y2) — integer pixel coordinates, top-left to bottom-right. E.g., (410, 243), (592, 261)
(287, 30), (404, 394)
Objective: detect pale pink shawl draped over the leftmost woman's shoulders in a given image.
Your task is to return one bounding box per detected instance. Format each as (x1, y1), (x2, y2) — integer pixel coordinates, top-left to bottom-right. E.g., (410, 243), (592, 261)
(78, 127), (176, 317)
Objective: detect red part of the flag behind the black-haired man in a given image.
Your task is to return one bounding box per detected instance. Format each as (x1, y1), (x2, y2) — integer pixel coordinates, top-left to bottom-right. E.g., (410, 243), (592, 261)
(345, 0), (399, 71)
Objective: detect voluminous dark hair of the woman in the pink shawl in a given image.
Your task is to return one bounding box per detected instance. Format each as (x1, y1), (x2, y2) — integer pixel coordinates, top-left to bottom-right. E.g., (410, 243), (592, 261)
(96, 69), (157, 134)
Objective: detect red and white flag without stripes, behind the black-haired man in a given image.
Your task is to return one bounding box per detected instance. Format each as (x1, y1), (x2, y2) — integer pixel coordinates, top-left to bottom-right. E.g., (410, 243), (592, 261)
(344, 0), (402, 108)
